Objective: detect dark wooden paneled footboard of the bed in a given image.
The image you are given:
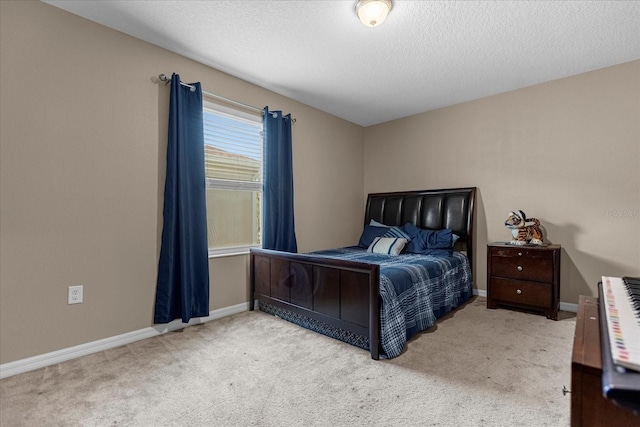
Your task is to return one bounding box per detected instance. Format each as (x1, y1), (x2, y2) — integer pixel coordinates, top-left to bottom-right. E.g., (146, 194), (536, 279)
(249, 249), (380, 360)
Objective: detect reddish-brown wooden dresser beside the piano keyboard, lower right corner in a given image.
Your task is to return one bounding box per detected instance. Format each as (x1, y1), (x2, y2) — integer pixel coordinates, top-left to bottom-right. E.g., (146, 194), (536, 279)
(571, 295), (640, 427)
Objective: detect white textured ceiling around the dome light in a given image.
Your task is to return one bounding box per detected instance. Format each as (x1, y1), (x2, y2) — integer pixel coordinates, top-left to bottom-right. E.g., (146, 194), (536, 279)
(45, 0), (640, 126)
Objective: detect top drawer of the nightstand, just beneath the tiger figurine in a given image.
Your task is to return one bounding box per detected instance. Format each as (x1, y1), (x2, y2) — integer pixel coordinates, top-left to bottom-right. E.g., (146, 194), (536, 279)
(491, 251), (553, 282)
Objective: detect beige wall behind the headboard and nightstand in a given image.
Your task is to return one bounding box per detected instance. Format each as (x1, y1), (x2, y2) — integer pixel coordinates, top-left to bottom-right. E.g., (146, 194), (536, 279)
(364, 61), (640, 303)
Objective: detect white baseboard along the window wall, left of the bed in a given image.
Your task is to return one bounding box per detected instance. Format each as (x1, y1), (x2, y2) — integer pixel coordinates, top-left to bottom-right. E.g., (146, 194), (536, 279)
(0, 302), (249, 379)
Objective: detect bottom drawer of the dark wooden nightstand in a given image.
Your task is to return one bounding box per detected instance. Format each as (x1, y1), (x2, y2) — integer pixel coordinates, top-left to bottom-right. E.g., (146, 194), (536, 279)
(490, 277), (553, 308)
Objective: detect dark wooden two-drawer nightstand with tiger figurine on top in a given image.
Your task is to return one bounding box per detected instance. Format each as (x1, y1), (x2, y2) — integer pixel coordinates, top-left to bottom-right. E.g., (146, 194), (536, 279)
(487, 242), (560, 320)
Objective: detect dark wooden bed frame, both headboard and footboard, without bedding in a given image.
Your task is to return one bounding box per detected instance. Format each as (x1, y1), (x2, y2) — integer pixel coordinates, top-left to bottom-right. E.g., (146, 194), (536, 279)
(249, 187), (476, 360)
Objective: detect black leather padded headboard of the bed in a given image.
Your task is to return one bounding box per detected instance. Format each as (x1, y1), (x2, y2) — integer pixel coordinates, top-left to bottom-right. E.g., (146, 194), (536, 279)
(364, 187), (476, 265)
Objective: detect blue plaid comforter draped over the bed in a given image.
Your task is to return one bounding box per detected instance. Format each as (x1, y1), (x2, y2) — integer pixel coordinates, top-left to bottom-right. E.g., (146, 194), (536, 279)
(309, 246), (473, 358)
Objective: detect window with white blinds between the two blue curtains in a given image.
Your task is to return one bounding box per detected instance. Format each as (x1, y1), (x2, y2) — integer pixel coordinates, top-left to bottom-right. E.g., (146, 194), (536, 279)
(204, 101), (262, 256)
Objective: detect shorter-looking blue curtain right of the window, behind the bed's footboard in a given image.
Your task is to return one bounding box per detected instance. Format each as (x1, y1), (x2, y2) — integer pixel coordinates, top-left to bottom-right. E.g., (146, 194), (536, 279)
(262, 107), (298, 252)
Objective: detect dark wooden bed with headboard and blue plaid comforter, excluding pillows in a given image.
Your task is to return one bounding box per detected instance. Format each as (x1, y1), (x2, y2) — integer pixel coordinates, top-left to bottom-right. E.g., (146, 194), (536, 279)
(249, 187), (475, 360)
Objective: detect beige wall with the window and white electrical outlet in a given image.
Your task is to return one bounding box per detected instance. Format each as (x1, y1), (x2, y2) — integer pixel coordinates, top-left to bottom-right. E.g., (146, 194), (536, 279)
(0, 1), (364, 363)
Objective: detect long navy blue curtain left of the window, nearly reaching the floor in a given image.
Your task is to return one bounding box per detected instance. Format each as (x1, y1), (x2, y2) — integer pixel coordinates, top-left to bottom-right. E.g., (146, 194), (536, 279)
(154, 74), (209, 323)
